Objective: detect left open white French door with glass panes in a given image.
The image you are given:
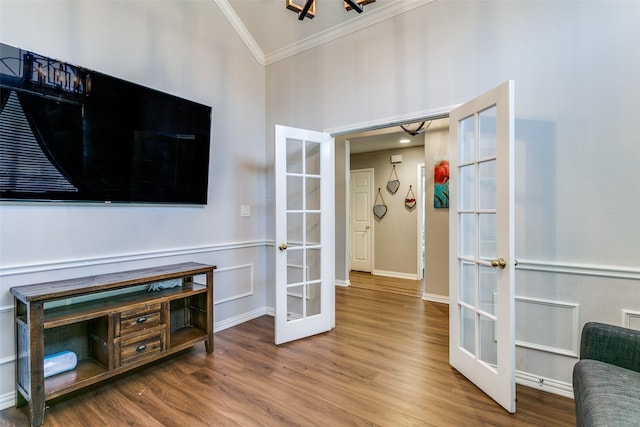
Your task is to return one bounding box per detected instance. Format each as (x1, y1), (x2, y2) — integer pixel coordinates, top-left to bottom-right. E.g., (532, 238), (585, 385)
(275, 125), (335, 344)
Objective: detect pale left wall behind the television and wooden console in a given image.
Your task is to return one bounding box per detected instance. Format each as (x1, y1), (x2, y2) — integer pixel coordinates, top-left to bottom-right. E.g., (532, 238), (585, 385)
(0, 0), (270, 409)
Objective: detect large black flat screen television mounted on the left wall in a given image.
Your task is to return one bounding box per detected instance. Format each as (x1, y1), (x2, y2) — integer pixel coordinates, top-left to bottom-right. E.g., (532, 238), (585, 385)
(0, 44), (212, 205)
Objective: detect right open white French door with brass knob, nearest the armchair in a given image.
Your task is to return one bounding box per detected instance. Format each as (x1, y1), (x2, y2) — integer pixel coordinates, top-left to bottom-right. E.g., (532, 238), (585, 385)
(449, 81), (516, 412)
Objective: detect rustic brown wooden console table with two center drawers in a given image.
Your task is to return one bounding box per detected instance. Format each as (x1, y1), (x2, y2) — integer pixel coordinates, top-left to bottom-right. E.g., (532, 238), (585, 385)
(11, 263), (216, 426)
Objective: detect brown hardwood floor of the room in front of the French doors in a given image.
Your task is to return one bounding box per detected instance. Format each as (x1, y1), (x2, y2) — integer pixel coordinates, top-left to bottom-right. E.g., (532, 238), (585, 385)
(0, 288), (575, 427)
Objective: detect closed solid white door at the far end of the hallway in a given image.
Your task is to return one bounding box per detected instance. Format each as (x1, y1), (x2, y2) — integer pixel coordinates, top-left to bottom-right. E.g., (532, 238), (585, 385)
(349, 169), (374, 273)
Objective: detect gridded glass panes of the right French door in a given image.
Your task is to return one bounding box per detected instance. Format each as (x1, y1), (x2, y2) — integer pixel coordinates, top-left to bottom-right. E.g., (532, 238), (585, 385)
(457, 106), (497, 371)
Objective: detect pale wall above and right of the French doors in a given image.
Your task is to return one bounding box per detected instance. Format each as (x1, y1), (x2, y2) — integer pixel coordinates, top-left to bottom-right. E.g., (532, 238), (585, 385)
(266, 1), (640, 395)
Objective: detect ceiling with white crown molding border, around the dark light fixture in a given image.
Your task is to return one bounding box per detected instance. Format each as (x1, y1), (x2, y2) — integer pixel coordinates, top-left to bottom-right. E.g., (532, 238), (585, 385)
(217, 0), (434, 65)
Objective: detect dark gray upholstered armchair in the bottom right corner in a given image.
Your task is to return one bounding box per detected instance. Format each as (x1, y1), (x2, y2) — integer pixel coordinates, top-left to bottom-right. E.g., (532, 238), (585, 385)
(573, 322), (640, 427)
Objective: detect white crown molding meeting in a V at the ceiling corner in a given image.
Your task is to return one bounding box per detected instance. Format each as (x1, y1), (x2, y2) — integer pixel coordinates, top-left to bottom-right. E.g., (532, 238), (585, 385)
(216, 0), (436, 65)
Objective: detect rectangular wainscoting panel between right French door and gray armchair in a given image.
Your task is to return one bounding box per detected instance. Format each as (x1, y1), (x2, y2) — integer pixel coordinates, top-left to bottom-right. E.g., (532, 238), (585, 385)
(515, 297), (580, 357)
